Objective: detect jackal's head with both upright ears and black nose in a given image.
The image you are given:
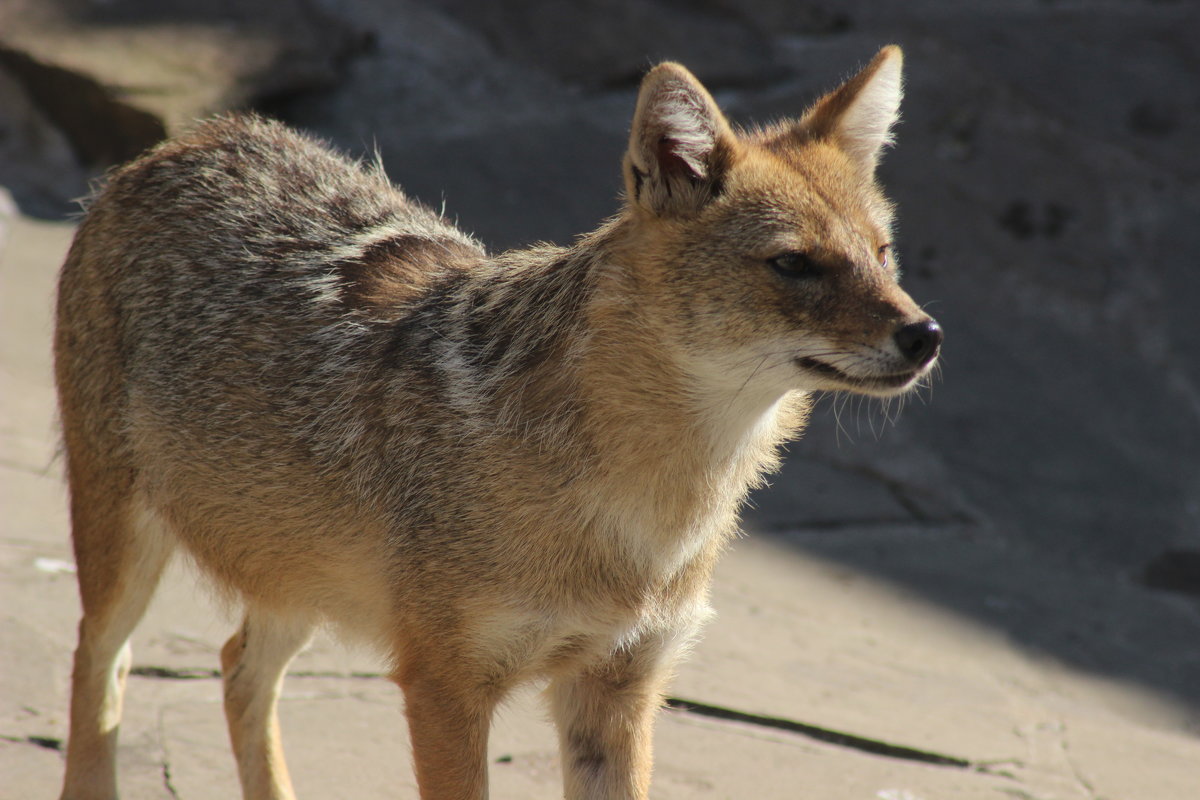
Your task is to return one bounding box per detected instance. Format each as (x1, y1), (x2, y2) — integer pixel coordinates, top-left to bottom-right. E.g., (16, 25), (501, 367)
(624, 47), (942, 396)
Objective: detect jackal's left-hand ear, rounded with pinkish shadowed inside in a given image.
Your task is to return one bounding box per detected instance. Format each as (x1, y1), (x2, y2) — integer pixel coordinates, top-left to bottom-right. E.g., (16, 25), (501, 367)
(624, 62), (734, 216)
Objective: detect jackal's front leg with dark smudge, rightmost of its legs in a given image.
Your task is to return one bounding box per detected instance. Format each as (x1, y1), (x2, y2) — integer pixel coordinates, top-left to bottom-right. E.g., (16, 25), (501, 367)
(550, 645), (674, 800)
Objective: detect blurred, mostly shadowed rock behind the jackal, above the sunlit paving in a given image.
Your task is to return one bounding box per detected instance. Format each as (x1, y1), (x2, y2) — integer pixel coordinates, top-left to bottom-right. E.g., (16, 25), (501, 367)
(0, 0), (1200, 762)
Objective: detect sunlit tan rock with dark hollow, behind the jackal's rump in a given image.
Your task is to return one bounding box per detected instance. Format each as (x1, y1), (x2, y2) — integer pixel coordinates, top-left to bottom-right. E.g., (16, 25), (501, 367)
(0, 0), (364, 216)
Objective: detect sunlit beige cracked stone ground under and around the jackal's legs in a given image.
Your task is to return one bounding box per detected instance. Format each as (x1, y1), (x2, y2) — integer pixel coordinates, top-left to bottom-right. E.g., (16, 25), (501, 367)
(0, 209), (1200, 800)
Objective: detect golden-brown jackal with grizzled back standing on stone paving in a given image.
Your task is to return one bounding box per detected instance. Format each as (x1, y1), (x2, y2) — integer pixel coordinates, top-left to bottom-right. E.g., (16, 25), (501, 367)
(54, 47), (942, 799)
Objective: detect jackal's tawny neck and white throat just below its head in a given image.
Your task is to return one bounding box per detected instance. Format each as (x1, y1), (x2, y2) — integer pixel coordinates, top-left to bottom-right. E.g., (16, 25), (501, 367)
(566, 222), (808, 524)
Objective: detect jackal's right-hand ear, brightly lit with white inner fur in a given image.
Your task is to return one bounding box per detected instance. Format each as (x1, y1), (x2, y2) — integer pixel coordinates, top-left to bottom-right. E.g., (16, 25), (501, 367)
(799, 44), (904, 172)
